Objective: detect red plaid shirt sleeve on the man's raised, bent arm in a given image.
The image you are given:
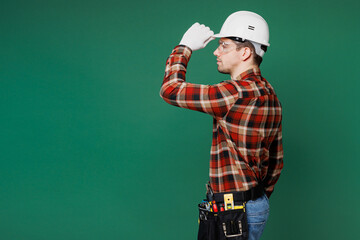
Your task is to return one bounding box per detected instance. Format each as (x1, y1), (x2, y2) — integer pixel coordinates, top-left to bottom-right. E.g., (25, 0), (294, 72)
(160, 45), (239, 117)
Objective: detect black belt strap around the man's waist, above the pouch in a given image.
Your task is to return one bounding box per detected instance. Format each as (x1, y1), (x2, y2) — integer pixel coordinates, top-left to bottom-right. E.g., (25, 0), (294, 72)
(213, 184), (264, 203)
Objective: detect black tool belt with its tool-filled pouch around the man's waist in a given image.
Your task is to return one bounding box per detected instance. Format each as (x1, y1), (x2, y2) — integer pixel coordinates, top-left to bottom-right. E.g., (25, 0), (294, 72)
(198, 184), (264, 240)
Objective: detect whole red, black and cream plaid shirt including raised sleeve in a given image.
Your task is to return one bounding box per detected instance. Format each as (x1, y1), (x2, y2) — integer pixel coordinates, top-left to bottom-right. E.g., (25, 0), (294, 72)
(160, 46), (283, 196)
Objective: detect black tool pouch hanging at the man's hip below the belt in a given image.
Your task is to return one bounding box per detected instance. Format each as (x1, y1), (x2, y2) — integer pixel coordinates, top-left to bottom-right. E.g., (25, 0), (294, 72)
(198, 204), (249, 240)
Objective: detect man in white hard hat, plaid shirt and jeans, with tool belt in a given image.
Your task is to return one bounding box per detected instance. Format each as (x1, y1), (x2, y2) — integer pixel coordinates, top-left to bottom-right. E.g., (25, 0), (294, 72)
(160, 11), (283, 240)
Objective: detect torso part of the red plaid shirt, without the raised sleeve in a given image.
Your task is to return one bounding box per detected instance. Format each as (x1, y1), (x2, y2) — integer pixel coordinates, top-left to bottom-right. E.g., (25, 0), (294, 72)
(210, 69), (282, 196)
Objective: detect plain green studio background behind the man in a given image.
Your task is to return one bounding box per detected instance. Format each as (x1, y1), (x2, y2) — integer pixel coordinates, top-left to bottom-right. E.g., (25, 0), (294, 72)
(0, 0), (360, 240)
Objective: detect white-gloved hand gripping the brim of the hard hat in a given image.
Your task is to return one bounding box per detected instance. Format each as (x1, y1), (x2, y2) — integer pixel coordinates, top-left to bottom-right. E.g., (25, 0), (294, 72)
(180, 23), (215, 51)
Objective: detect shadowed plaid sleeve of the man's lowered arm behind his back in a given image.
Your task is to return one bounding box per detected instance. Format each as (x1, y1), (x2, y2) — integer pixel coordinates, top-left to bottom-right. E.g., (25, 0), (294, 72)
(263, 124), (284, 197)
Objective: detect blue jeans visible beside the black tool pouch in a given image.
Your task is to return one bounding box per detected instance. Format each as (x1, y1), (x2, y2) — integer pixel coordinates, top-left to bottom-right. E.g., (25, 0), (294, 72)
(246, 194), (269, 240)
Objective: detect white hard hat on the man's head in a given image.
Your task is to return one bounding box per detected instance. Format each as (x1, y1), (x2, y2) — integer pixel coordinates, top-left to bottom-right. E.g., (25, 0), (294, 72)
(213, 11), (270, 57)
